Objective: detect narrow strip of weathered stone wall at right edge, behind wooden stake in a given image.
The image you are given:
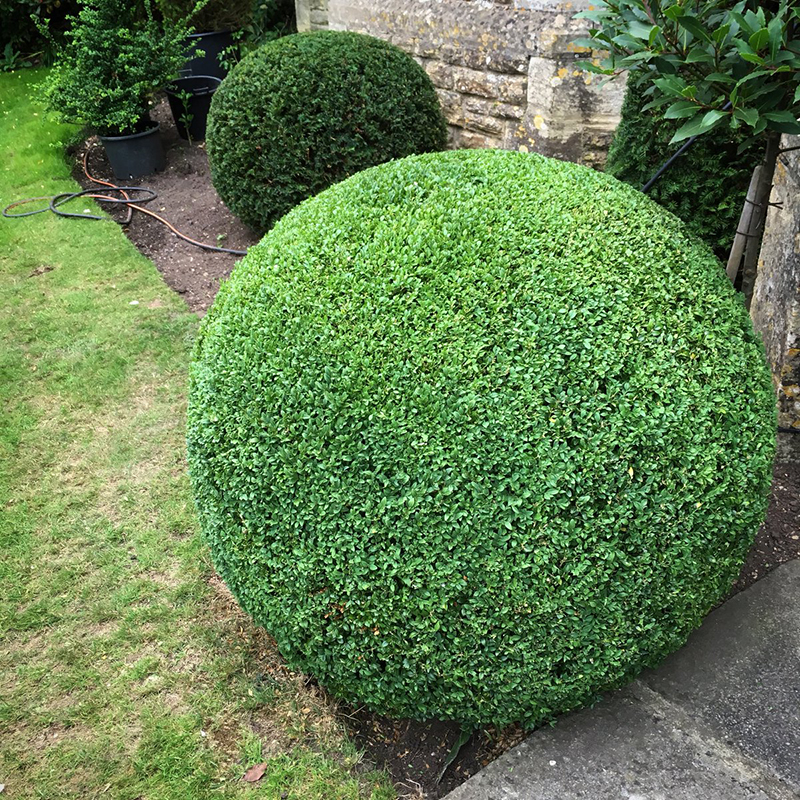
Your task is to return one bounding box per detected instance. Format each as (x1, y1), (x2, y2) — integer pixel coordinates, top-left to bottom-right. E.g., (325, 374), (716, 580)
(750, 136), (800, 428)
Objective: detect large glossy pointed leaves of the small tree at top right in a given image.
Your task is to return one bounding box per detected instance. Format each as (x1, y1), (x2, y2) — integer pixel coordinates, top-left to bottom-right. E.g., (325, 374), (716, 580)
(577, 0), (800, 142)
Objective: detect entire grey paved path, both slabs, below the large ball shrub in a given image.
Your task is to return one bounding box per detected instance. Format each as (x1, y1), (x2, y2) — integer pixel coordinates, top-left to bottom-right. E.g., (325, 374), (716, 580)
(446, 561), (800, 800)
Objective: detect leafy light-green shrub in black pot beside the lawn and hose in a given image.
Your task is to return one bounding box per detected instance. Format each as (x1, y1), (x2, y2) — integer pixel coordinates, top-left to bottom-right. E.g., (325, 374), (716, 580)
(44, 0), (198, 180)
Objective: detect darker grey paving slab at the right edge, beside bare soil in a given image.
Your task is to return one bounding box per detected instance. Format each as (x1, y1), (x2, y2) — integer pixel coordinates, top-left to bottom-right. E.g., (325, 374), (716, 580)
(640, 561), (800, 797)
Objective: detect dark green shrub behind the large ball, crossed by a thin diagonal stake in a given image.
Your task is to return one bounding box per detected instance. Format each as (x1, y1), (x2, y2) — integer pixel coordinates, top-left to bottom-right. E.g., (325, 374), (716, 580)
(606, 80), (764, 258)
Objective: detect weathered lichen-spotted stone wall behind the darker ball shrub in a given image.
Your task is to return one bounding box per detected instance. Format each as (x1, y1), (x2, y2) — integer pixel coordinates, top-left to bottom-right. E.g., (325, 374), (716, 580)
(296, 0), (624, 166)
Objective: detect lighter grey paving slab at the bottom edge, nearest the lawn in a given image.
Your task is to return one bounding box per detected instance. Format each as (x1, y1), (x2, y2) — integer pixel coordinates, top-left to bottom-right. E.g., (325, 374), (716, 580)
(447, 689), (786, 800)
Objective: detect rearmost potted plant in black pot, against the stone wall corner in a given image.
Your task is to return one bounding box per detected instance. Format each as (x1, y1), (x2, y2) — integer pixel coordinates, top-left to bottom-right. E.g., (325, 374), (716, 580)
(159, 0), (253, 78)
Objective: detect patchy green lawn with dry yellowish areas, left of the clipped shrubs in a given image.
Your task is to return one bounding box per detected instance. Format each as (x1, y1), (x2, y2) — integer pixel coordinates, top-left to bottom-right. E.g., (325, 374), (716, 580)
(0, 71), (394, 800)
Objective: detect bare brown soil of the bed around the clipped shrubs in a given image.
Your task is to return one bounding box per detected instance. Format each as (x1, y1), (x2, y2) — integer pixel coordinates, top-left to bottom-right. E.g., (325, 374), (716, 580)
(70, 114), (800, 798)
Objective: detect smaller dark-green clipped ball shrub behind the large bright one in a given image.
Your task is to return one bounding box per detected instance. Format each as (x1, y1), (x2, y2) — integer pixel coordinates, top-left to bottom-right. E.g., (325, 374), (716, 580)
(206, 31), (447, 231)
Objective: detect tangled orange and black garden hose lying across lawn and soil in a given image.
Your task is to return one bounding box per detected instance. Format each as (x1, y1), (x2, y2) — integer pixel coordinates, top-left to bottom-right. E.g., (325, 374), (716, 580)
(3, 150), (247, 256)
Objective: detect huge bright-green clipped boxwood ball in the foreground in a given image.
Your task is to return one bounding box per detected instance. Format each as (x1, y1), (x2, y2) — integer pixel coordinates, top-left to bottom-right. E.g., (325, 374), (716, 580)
(188, 151), (775, 725)
